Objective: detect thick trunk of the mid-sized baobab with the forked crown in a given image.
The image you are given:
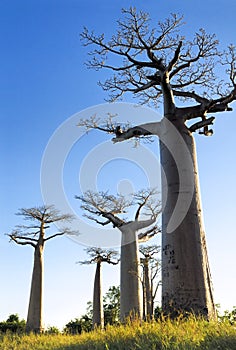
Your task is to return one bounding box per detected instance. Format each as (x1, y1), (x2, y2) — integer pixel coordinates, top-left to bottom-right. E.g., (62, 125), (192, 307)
(120, 230), (142, 321)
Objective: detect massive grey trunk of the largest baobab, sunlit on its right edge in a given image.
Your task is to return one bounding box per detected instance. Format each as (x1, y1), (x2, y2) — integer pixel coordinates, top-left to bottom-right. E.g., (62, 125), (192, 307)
(160, 121), (216, 319)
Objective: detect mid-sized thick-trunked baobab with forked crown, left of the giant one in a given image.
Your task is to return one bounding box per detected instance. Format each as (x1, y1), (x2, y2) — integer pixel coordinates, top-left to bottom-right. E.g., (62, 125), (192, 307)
(76, 190), (160, 321)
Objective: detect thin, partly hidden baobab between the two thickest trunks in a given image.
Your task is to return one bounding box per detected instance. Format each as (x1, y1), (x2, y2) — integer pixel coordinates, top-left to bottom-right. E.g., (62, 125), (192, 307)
(139, 245), (161, 319)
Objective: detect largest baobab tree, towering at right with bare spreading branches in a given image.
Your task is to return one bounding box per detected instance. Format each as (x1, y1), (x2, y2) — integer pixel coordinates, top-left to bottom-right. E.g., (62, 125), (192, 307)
(79, 8), (236, 318)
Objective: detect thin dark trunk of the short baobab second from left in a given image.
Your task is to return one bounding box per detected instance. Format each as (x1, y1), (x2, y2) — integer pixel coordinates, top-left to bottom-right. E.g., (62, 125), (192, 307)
(93, 262), (104, 328)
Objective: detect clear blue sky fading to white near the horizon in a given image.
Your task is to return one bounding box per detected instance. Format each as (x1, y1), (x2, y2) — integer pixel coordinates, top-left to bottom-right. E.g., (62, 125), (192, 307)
(0, 0), (236, 327)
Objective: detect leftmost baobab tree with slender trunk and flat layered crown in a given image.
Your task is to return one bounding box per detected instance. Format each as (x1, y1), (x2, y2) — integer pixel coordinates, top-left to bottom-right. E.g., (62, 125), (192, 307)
(8, 205), (75, 333)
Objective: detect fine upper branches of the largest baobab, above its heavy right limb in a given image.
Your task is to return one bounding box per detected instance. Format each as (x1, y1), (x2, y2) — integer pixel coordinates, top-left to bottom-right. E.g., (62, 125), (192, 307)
(81, 7), (236, 104)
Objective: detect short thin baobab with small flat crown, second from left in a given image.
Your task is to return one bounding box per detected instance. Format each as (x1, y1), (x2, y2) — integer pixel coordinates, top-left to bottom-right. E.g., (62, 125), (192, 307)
(80, 247), (119, 328)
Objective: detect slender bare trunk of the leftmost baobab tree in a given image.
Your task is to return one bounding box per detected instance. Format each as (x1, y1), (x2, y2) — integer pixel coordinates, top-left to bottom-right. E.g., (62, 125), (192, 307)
(26, 244), (43, 333)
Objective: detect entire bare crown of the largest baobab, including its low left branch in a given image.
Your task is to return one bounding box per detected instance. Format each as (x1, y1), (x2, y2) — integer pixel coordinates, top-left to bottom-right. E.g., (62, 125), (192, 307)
(79, 7), (236, 137)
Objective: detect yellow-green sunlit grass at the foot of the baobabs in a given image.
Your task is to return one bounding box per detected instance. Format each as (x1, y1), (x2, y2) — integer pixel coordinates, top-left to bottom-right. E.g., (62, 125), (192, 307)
(0, 317), (236, 350)
